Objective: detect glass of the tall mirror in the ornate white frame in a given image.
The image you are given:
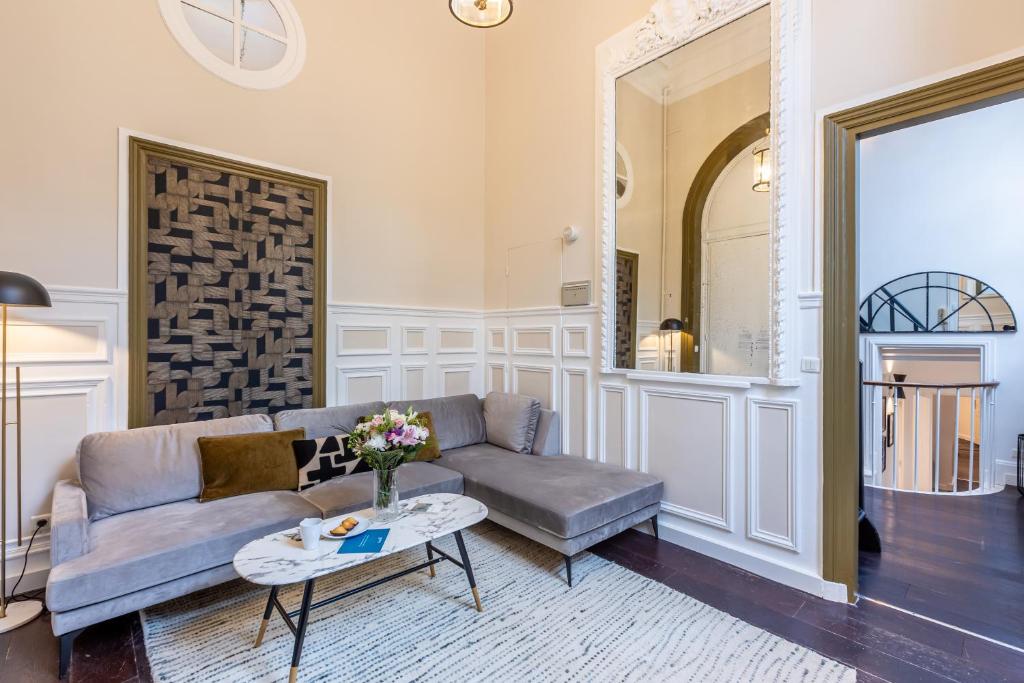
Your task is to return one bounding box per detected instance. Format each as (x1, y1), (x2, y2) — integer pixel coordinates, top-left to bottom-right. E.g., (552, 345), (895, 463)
(612, 6), (772, 377)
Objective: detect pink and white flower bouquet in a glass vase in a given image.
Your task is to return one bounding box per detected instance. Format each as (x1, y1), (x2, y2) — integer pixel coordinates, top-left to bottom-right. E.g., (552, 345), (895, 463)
(348, 407), (430, 522)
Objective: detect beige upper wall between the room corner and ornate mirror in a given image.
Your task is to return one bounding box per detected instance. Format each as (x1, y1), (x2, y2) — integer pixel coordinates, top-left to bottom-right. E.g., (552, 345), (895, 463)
(484, 0), (652, 308)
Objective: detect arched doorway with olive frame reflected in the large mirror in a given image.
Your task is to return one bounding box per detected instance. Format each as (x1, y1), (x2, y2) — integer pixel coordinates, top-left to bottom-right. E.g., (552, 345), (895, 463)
(681, 113), (770, 376)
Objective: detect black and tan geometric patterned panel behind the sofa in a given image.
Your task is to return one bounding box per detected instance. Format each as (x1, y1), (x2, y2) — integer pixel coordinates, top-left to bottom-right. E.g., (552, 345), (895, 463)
(136, 154), (319, 426)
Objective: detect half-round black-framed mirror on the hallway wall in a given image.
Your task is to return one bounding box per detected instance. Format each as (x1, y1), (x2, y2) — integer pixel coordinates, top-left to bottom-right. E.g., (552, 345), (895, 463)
(860, 270), (1017, 334)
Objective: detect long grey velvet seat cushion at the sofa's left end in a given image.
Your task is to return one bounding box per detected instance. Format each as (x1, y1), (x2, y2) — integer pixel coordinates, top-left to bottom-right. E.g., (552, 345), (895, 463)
(46, 490), (319, 611)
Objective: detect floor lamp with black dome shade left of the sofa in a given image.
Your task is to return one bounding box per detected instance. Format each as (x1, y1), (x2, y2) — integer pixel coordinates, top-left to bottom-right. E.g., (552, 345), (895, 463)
(0, 270), (50, 633)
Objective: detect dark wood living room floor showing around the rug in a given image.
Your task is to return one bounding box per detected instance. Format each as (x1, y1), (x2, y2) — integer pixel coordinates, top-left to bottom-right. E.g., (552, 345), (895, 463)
(0, 530), (1024, 683)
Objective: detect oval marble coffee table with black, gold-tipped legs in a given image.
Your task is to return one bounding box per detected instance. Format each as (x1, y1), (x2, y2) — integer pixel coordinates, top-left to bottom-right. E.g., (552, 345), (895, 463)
(234, 494), (487, 683)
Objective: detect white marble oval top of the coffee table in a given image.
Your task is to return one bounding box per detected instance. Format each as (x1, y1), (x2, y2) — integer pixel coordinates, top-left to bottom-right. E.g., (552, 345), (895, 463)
(234, 494), (487, 586)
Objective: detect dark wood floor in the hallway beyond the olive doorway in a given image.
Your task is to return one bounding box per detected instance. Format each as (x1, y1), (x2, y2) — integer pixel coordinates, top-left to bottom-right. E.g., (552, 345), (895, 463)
(860, 487), (1024, 651)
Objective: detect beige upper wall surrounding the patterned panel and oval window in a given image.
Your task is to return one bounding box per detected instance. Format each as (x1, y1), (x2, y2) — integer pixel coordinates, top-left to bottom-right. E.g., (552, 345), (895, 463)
(0, 0), (487, 308)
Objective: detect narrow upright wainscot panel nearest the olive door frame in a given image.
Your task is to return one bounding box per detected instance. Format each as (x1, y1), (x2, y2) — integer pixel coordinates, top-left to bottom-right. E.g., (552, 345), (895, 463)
(746, 398), (800, 550)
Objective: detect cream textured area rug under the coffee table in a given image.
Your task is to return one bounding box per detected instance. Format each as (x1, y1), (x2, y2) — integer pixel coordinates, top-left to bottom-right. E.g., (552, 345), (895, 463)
(142, 522), (856, 683)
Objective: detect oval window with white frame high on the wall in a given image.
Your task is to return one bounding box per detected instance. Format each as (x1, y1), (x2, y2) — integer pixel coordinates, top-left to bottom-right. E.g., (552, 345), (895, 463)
(160, 0), (306, 89)
